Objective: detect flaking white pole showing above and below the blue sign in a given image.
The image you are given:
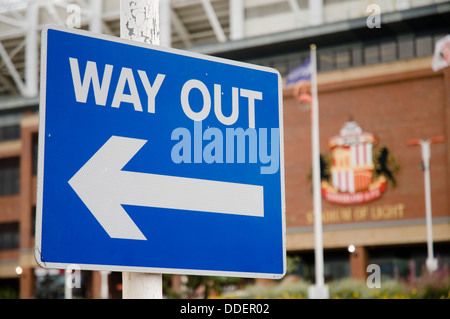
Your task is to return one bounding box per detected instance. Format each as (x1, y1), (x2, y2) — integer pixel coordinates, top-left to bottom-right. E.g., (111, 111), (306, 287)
(120, 0), (162, 299)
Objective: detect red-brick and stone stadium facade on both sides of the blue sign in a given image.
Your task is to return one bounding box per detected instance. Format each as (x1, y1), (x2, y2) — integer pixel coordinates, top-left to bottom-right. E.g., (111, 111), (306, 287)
(0, 58), (450, 298)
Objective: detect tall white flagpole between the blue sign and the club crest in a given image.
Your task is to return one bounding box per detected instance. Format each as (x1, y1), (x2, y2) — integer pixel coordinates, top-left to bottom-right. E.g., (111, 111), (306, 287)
(308, 44), (329, 299)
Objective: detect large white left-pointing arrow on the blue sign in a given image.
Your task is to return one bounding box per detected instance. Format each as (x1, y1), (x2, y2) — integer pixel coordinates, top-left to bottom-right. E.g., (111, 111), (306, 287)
(69, 136), (264, 240)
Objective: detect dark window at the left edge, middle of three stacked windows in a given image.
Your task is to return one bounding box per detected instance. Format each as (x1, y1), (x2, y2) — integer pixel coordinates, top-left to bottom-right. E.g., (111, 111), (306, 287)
(0, 157), (20, 196)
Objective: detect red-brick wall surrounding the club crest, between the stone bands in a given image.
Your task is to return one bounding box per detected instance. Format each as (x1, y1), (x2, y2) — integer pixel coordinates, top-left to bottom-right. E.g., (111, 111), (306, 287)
(284, 58), (450, 232)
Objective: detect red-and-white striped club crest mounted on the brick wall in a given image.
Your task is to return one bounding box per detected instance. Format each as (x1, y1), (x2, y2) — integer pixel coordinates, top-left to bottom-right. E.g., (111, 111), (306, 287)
(321, 121), (399, 204)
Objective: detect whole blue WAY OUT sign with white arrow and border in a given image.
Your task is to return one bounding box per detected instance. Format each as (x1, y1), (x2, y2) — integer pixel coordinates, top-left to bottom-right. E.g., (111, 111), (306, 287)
(36, 26), (286, 278)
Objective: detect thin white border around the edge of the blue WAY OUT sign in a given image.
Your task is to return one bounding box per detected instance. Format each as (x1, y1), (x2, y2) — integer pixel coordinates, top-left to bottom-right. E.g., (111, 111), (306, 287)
(34, 25), (286, 279)
